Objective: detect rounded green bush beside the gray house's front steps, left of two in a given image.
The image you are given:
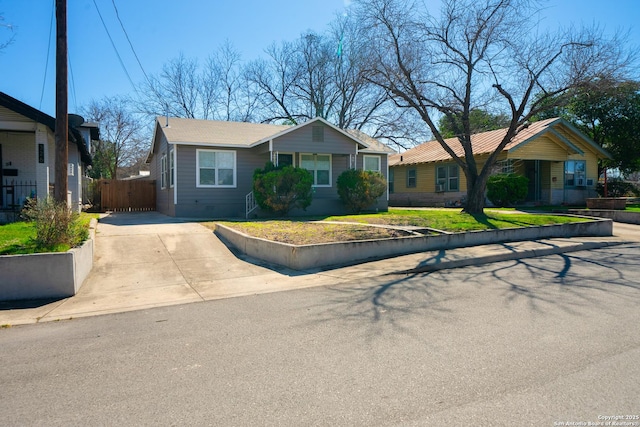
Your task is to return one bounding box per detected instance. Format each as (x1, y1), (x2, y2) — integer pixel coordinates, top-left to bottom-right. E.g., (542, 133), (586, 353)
(253, 162), (313, 216)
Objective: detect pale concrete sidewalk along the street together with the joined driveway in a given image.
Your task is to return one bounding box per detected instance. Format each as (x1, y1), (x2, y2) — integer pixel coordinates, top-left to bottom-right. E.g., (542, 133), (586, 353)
(0, 213), (640, 326)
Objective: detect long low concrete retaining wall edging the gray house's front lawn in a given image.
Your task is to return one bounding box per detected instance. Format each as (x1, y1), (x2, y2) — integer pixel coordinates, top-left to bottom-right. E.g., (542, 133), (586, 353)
(215, 219), (613, 270)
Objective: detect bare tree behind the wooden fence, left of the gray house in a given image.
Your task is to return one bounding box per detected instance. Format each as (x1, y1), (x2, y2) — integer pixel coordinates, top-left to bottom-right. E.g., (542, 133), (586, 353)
(83, 97), (148, 179)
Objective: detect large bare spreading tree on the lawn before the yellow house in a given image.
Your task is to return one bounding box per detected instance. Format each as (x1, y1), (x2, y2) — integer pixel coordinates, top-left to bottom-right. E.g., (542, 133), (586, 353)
(354, 0), (630, 213)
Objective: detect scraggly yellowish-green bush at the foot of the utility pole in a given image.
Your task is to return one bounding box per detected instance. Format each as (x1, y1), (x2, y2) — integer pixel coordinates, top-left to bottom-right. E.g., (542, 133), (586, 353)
(22, 197), (89, 251)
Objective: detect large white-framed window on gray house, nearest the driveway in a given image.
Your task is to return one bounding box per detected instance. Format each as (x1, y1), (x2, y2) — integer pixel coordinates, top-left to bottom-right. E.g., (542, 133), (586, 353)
(196, 150), (236, 188)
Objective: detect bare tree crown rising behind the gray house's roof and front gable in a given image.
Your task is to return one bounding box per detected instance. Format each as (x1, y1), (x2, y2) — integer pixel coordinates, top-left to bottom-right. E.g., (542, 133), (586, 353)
(247, 17), (416, 147)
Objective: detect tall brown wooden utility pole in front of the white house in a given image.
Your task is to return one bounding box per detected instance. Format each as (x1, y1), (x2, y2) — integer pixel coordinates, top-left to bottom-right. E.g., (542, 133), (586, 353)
(53, 0), (69, 204)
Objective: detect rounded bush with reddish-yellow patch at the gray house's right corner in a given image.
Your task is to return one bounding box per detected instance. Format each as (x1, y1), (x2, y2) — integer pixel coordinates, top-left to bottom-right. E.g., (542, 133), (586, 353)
(337, 169), (387, 213)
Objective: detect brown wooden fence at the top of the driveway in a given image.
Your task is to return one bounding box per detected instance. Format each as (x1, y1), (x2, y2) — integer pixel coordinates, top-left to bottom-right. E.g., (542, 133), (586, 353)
(99, 179), (156, 212)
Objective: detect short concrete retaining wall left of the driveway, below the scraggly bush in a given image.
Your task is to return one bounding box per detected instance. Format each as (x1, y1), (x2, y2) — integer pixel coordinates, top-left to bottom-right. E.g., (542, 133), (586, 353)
(0, 220), (95, 301)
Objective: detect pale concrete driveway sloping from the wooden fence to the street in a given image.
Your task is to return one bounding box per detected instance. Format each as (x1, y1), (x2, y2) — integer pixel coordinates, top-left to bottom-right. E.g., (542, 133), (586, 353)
(26, 212), (342, 320)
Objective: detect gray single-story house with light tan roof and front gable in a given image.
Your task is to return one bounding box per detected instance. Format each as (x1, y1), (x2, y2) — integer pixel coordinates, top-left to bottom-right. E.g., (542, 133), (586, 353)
(147, 117), (394, 218)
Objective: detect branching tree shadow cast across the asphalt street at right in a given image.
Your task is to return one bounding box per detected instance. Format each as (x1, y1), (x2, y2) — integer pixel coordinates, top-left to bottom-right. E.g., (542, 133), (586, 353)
(308, 244), (640, 337)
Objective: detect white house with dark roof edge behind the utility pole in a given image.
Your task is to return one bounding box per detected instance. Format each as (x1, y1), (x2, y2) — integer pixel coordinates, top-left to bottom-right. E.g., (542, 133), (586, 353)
(0, 92), (99, 220)
